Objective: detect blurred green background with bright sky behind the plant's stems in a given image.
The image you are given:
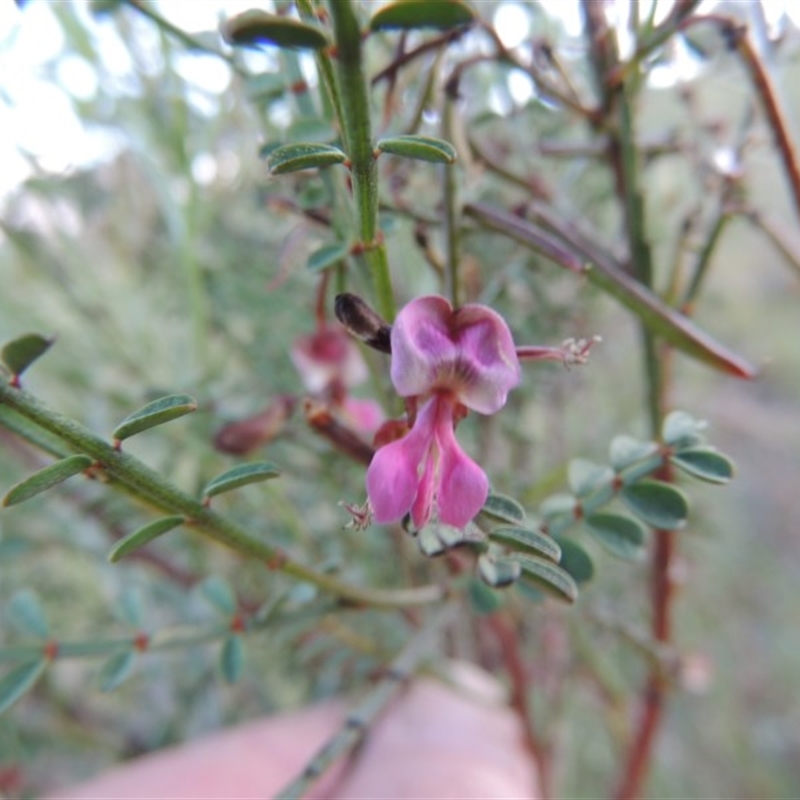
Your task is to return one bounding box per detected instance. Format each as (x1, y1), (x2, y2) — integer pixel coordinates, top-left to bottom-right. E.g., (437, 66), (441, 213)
(0, 0), (800, 799)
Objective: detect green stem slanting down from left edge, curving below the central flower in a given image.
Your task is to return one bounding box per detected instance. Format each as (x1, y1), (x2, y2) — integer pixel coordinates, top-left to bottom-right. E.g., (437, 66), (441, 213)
(0, 384), (445, 608)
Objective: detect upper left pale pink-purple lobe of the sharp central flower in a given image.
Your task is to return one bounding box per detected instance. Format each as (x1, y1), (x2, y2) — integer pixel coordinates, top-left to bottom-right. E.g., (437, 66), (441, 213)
(391, 296), (458, 397)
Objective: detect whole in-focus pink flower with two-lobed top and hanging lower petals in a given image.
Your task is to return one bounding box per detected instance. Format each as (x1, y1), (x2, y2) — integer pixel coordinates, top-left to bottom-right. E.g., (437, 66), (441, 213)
(367, 297), (520, 528)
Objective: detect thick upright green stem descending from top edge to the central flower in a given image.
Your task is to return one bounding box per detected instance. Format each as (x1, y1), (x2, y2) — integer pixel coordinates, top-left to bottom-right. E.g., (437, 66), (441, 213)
(328, 0), (395, 322)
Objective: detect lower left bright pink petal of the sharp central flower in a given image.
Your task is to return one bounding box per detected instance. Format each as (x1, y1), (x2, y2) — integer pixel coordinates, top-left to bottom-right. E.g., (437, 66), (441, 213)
(367, 399), (436, 523)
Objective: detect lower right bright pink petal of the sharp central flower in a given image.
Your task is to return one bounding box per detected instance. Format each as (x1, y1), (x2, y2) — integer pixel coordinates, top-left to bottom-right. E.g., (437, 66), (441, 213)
(436, 406), (489, 528)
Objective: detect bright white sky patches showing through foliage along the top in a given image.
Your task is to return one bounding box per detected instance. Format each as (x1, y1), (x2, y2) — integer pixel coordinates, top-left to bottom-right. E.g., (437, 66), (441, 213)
(0, 0), (800, 199)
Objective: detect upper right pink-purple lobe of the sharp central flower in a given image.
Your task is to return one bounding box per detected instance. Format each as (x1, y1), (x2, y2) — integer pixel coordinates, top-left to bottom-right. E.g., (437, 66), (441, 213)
(454, 305), (521, 414)
